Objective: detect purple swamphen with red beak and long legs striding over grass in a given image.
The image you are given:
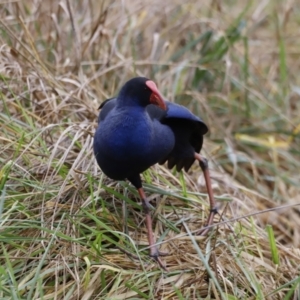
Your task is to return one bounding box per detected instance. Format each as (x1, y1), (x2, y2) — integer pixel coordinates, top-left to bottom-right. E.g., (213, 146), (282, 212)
(94, 77), (217, 268)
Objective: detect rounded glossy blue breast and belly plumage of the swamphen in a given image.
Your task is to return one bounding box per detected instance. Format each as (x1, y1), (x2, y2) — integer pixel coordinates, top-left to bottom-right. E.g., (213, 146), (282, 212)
(94, 102), (175, 185)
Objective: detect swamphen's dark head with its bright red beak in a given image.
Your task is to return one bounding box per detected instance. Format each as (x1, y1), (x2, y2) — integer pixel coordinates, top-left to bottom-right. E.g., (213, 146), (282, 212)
(118, 77), (167, 110)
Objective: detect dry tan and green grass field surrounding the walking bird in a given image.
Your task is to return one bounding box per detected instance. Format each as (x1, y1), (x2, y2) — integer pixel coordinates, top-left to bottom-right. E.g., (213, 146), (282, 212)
(0, 0), (300, 300)
